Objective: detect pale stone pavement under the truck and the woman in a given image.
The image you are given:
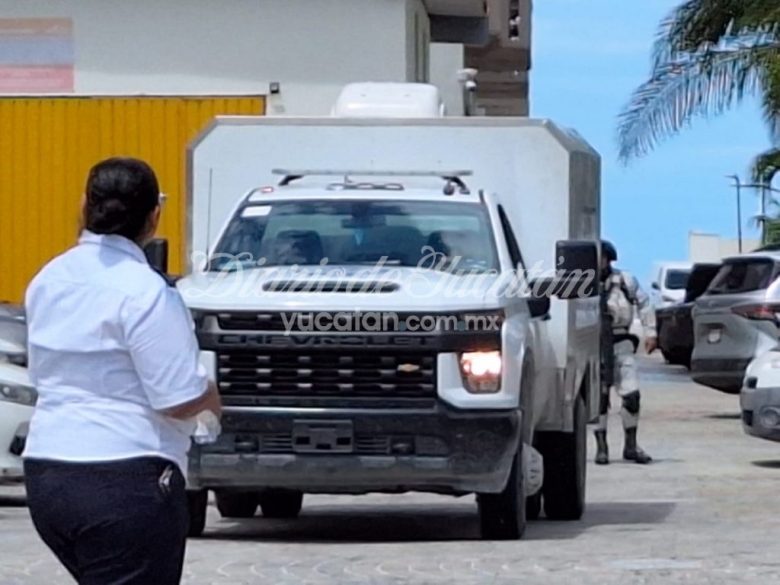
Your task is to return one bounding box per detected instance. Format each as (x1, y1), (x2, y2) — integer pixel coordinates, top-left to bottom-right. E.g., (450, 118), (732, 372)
(0, 354), (780, 585)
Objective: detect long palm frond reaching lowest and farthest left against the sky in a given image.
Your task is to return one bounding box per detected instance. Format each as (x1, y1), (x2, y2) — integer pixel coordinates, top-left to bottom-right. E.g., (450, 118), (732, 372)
(618, 35), (780, 162)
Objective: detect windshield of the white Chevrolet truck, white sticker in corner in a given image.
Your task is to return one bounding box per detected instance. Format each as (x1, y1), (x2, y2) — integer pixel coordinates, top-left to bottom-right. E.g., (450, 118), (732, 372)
(209, 200), (498, 272)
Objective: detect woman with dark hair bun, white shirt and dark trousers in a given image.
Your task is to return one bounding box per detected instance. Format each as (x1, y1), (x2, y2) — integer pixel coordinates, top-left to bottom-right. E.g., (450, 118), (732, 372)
(24, 158), (221, 585)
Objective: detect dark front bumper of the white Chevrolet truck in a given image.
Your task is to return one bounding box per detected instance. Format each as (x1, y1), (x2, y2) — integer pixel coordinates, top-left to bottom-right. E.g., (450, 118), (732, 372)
(188, 405), (522, 494)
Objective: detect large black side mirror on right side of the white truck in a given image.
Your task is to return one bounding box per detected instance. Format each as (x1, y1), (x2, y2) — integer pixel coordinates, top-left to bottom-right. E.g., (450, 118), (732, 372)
(554, 240), (600, 300)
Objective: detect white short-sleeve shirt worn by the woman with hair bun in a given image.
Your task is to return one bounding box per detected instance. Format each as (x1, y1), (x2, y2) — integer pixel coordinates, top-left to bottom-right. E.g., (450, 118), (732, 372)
(24, 231), (208, 473)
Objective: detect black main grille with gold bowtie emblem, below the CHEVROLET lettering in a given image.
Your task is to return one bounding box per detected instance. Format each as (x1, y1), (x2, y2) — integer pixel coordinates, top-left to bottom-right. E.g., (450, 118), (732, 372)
(217, 349), (436, 407)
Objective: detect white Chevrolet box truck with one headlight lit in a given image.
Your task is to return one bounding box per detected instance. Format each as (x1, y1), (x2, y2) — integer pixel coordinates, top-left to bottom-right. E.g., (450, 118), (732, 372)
(178, 82), (600, 538)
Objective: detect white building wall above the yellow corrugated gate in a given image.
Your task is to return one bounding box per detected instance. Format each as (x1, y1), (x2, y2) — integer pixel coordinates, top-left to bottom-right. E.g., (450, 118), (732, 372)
(0, 0), (420, 115)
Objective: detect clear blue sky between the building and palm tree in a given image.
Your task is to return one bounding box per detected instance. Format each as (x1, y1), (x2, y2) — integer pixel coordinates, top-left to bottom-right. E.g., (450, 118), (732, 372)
(531, 0), (769, 284)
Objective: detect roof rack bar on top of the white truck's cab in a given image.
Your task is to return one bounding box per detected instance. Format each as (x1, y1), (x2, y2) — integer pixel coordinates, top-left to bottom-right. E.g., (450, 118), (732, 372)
(271, 169), (473, 195)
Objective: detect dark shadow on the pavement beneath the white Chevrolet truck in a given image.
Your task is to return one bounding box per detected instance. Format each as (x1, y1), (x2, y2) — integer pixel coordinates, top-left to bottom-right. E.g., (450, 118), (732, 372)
(201, 502), (675, 544)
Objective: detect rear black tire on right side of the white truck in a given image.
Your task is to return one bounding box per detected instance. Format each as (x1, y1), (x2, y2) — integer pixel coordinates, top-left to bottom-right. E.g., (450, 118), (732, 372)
(538, 396), (587, 520)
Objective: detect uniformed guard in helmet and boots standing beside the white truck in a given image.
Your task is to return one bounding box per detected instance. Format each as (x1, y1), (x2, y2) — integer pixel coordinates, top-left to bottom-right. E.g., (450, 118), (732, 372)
(596, 241), (657, 465)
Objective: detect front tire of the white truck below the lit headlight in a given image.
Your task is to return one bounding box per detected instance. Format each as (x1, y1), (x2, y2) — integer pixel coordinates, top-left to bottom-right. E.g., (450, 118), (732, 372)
(477, 443), (526, 540)
